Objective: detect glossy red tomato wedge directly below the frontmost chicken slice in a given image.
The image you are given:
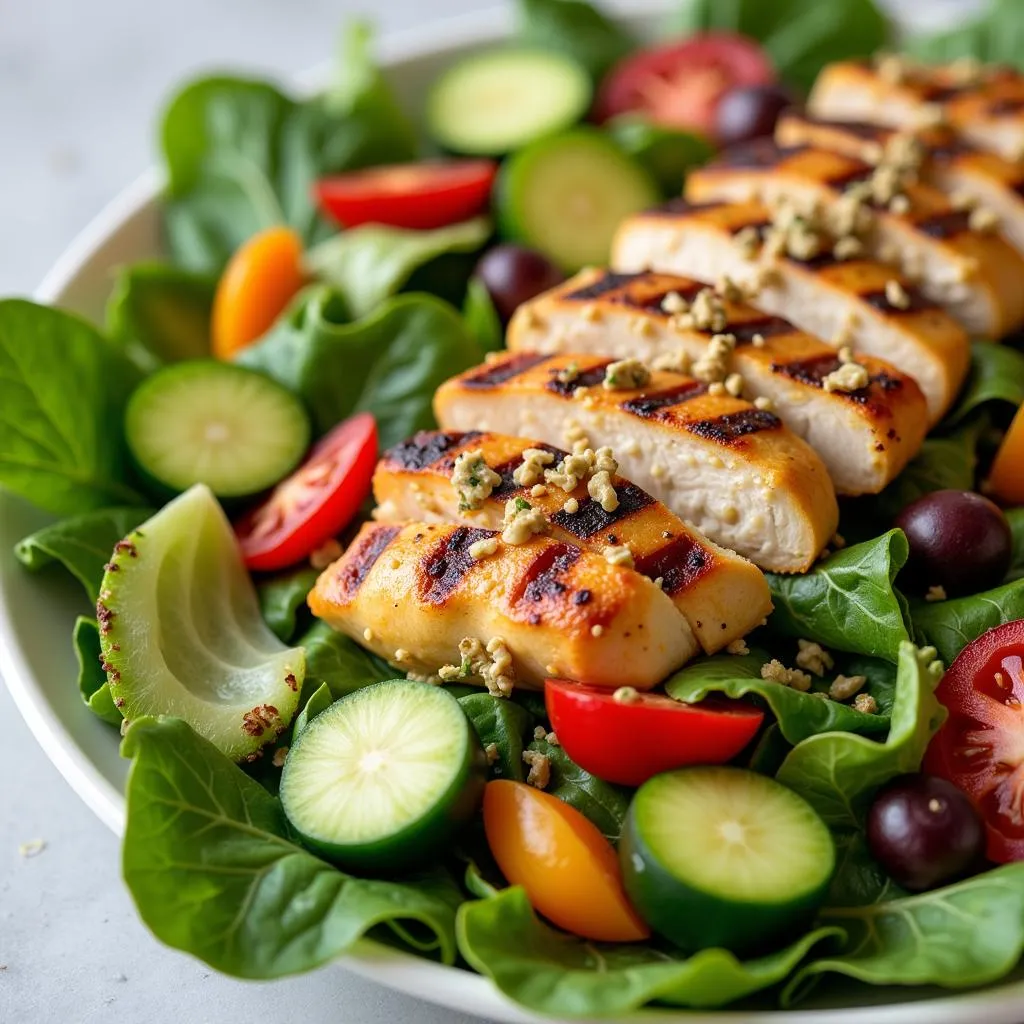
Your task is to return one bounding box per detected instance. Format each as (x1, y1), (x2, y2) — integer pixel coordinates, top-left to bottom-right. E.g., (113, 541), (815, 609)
(544, 679), (764, 785)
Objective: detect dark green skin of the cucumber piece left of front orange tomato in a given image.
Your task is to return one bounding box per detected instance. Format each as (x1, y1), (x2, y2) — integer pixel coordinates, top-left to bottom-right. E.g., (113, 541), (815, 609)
(281, 691), (487, 874)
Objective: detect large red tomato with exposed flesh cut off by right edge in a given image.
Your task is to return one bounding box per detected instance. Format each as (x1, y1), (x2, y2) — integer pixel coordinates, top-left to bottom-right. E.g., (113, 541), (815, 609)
(925, 621), (1024, 864)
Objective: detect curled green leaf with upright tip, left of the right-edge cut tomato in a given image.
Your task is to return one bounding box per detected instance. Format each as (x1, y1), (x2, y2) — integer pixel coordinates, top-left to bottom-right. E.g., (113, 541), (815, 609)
(776, 642), (946, 828)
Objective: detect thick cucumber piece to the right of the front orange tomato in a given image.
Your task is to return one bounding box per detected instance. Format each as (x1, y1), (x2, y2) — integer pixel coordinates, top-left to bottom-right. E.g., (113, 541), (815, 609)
(620, 767), (836, 953)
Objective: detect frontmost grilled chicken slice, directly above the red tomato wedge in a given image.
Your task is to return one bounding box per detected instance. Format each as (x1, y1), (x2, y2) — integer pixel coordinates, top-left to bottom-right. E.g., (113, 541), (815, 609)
(309, 522), (698, 689)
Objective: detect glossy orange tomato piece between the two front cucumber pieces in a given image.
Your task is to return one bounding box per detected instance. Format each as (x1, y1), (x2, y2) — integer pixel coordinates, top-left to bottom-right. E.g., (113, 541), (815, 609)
(483, 780), (650, 942)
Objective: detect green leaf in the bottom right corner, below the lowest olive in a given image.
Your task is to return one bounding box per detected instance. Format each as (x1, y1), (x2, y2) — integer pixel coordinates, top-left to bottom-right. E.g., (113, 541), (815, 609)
(783, 864), (1024, 1005)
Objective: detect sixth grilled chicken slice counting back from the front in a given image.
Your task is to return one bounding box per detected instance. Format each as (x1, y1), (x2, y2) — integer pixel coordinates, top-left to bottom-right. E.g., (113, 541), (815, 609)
(686, 140), (1024, 338)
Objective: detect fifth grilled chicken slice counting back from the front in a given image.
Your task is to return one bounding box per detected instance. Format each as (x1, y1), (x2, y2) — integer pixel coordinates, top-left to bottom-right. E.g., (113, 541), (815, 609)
(611, 200), (971, 423)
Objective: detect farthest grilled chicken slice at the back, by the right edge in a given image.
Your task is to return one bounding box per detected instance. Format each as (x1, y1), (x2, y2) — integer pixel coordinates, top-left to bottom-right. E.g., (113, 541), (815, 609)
(807, 57), (1024, 161)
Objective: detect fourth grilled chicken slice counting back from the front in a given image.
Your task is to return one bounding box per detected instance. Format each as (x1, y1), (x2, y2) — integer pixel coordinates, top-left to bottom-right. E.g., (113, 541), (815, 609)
(508, 269), (929, 495)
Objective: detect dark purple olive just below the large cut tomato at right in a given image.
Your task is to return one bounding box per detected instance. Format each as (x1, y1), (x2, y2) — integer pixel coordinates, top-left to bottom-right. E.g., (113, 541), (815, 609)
(867, 775), (985, 892)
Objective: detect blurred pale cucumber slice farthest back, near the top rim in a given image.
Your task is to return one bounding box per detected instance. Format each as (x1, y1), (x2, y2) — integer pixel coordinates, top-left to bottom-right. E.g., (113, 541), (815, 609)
(427, 47), (592, 157)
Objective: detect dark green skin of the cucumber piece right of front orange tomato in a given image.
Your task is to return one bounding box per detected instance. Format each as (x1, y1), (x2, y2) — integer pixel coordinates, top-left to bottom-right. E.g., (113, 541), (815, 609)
(618, 798), (831, 954)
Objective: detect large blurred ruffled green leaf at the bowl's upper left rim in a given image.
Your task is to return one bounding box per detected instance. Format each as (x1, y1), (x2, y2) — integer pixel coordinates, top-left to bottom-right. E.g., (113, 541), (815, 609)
(161, 25), (415, 273)
